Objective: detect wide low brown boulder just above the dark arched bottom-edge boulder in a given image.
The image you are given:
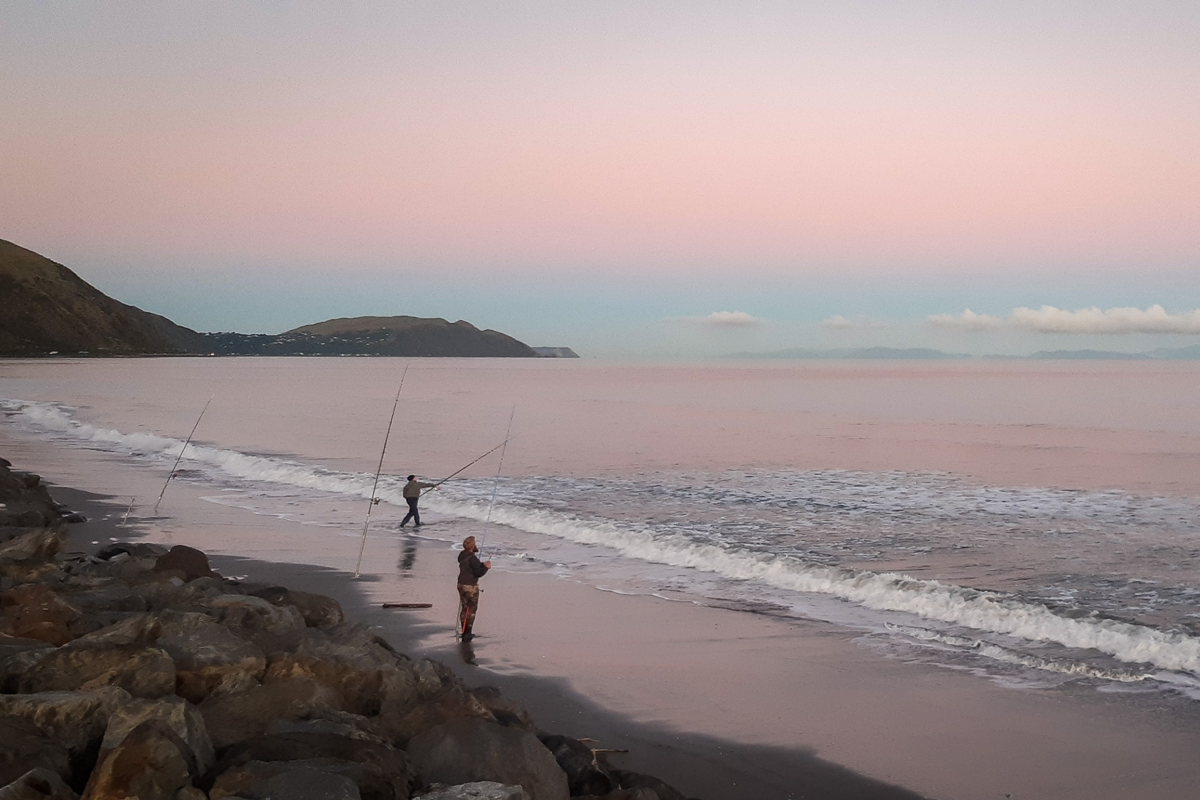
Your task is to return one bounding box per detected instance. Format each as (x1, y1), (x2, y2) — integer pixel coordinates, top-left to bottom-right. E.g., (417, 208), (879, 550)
(200, 678), (346, 750)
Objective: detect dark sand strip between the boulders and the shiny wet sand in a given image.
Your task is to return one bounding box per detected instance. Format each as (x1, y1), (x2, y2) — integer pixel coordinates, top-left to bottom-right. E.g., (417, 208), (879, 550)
(43, 476), (922, 800)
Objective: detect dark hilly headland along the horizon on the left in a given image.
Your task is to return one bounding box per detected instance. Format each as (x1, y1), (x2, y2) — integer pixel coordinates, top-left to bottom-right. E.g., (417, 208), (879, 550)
(0, 240), (578, 359)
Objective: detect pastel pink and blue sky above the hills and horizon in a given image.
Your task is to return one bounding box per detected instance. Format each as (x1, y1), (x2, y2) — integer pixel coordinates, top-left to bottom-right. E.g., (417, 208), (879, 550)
(0, 0), (1200, 357)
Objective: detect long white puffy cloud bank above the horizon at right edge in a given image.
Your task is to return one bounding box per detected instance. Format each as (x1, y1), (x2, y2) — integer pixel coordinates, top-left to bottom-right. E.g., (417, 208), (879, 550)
(928, 305), (1200, 333)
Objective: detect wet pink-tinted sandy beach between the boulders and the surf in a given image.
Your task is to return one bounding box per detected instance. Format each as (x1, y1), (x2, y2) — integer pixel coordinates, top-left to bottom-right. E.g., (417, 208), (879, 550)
(14, 434), (1200, 800)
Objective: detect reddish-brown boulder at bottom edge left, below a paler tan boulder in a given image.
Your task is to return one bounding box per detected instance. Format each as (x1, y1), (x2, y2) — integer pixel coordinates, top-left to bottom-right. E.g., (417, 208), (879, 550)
(83, 720), (191, 800)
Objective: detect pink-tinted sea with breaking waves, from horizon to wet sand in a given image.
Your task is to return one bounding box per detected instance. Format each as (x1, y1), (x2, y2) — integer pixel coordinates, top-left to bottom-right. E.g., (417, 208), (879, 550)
(0, 359), (1200, 698)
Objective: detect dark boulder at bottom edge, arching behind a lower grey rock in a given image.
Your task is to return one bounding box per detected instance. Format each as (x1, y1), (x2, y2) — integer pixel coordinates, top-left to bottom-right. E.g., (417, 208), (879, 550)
(211, 733), (415, 800)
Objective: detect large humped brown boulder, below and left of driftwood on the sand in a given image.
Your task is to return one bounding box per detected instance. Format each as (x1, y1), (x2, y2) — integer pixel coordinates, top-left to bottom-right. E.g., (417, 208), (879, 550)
(264, 625), (418, 717)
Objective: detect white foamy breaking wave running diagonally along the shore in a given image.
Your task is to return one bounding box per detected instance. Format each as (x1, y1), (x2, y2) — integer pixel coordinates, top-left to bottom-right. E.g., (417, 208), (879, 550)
(7, 401), (1200, 674)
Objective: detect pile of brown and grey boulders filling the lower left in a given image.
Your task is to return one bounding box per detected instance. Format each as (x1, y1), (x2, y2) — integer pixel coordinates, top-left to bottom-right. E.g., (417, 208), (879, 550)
(0, 459), (685, 800)
